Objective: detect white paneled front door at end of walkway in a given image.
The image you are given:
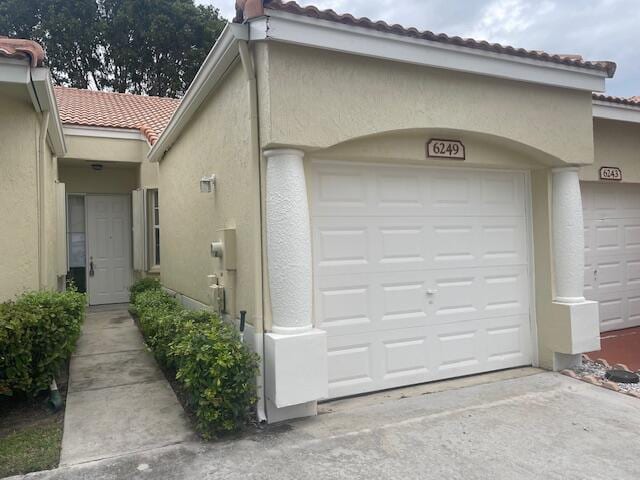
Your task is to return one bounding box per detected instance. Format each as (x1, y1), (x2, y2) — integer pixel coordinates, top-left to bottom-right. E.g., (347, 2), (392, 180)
(86, 195), (132, 305)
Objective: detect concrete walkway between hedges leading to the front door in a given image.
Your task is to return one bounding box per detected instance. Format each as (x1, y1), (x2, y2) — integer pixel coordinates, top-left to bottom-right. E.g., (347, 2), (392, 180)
(60, 305), (194, 466)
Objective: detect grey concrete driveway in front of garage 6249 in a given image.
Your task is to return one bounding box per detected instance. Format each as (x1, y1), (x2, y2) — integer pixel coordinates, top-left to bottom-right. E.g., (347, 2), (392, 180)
(13, 369), (640, 480)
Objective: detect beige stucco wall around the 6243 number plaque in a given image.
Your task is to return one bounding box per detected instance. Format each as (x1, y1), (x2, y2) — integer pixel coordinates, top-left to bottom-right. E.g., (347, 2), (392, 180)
(580, 118), (640, 183)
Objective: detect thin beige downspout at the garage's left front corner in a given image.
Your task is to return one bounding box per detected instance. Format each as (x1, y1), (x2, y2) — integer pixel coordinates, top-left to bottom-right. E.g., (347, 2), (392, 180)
(234, 24), (267, 421)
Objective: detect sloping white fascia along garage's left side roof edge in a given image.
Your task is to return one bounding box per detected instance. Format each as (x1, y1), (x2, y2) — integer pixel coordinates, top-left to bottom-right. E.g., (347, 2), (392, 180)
(147, 23), (248, 162)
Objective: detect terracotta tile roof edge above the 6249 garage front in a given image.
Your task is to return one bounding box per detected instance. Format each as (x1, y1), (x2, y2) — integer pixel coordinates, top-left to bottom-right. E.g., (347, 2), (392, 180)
(234, 0), (616, 77)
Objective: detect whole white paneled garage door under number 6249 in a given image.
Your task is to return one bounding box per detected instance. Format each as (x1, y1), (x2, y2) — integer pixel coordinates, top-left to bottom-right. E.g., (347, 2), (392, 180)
(310, 161), (532, 397)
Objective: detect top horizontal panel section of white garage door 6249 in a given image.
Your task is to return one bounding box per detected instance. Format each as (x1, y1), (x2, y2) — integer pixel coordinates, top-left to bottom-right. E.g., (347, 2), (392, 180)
(310, 161), (525, 217)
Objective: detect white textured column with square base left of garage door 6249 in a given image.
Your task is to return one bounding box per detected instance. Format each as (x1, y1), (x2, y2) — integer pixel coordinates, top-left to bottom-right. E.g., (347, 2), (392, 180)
(264, 149), (329, 423)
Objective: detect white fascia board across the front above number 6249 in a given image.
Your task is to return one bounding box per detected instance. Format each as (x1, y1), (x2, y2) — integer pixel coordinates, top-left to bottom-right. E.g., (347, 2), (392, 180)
(250, 10), (607, 93)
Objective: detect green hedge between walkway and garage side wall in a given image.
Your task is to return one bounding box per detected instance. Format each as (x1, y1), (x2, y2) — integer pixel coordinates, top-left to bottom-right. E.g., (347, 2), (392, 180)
(132, 280), (258, 438)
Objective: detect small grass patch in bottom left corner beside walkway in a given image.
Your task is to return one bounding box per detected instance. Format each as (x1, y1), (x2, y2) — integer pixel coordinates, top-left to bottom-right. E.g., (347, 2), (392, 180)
(0, 418), (62, 478)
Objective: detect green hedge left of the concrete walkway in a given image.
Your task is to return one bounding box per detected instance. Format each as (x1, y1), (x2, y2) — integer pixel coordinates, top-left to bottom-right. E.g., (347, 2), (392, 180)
(0, 289), (86, 395)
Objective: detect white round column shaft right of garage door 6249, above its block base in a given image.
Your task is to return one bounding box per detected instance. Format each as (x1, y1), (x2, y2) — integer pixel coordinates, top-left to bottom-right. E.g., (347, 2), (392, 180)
(552, 167), (585, 303)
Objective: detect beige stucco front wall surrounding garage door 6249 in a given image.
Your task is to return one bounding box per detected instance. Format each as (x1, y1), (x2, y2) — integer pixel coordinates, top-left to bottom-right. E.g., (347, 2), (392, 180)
(256, 44), (594, 368)
